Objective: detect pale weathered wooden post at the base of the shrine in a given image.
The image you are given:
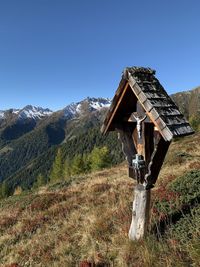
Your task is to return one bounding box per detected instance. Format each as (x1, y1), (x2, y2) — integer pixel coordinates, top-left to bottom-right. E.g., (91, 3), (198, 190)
(129, 184), (151, 240)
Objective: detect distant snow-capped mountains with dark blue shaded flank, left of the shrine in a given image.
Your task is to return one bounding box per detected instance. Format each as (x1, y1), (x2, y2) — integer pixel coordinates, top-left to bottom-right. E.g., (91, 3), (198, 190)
(0, 97), (111, 143)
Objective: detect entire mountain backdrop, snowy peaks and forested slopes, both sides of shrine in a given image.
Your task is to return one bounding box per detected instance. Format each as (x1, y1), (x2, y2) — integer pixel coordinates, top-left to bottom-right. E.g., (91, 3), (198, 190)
(0, 88), (200, 194)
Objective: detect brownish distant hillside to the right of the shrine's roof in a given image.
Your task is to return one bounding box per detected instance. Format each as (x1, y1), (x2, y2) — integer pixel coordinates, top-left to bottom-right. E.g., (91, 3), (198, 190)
(171, 87), (200, 119)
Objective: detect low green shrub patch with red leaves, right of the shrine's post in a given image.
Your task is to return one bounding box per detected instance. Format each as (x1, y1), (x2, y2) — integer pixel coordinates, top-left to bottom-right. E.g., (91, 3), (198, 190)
(152, 173), (200, 227)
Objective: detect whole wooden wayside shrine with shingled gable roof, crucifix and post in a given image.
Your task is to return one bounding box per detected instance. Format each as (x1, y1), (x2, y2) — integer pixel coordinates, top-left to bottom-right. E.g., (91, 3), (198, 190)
(101, 67), (194, 240)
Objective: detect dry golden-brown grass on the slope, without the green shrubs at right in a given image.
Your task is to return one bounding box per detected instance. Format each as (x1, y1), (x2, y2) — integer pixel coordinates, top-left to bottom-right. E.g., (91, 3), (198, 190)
(0, 134), (200, 267)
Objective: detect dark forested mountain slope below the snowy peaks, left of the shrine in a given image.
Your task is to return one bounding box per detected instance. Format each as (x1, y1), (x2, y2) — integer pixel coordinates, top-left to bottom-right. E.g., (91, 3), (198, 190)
(0, 108), (124, 194)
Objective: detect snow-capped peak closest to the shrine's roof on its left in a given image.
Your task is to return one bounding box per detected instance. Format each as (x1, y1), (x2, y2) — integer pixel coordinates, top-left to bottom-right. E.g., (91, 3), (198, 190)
(63, 97), (111, 118)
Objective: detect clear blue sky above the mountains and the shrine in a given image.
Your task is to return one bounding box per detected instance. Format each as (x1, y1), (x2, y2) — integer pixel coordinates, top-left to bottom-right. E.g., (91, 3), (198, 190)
(0, 0), (200, 110)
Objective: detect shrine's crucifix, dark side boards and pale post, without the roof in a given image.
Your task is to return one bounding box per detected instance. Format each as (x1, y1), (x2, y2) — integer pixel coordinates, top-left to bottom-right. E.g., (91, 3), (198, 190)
(118, 101), (169, 240)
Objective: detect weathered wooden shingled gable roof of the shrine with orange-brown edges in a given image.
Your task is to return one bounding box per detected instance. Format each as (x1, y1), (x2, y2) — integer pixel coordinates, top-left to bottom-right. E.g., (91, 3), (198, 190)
(101, 67), (194, 141)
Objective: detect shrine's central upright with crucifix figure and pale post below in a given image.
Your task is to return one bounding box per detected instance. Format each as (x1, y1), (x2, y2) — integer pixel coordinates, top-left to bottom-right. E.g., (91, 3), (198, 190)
(126, 102), (151, 240)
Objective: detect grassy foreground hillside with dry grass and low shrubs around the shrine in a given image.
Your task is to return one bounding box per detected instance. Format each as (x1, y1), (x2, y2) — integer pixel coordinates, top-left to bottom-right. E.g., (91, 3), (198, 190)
(0, 133), (200, 267)
